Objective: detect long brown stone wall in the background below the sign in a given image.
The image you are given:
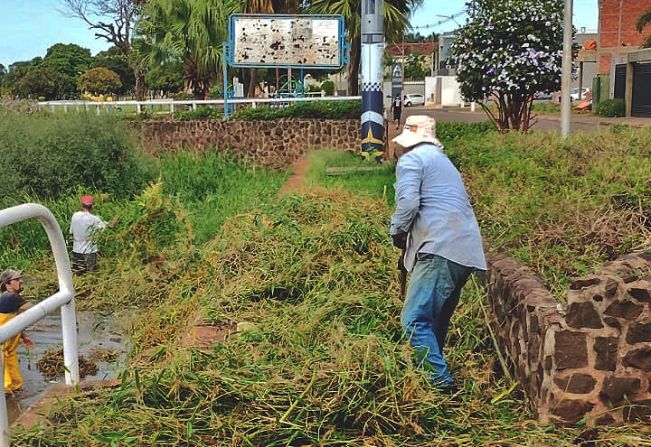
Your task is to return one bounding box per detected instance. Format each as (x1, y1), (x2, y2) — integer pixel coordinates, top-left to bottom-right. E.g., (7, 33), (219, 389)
(141, 118), (361, 168)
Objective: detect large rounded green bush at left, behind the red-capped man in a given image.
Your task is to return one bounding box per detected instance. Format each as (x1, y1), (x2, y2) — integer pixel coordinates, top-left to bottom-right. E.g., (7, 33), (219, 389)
(0, 112), (146, 205)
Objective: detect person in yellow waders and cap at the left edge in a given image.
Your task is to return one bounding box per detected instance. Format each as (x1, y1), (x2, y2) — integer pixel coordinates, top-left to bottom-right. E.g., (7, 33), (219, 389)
(0, 269), (34, 393)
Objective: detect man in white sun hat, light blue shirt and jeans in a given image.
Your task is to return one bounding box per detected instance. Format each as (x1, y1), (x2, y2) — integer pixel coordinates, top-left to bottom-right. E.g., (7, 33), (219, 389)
(389, 115), (486, 394)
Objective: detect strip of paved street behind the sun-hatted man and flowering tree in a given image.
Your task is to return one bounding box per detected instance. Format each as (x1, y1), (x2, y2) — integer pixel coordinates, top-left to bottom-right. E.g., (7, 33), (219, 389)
(403, 107), (651, 132)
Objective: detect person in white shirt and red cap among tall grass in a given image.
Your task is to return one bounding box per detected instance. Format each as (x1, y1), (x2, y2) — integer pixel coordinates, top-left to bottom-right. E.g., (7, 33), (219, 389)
(70, 195), (107, 274)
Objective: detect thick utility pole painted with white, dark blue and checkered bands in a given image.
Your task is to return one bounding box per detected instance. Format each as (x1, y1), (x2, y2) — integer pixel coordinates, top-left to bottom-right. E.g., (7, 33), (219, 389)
(361, 0), (385, 153)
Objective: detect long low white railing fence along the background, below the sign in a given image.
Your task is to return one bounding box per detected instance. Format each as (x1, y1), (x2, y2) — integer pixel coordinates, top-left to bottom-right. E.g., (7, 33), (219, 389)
(38, 95), (361, 115)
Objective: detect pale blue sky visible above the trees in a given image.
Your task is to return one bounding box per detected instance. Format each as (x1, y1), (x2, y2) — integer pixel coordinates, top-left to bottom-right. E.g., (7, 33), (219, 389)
(0, 0), (598, 67)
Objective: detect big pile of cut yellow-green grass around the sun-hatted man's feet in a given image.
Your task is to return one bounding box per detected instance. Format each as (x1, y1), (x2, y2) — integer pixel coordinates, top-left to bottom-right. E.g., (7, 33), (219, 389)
(13, 190), (651, 446)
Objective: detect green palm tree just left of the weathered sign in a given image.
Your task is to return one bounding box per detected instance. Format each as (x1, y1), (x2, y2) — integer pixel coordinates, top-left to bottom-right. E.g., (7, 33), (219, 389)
(137, 0), (241, 99)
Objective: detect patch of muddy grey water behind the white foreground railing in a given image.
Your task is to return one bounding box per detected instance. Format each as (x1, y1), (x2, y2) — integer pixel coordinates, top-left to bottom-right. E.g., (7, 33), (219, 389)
(7, 311), (129, 424)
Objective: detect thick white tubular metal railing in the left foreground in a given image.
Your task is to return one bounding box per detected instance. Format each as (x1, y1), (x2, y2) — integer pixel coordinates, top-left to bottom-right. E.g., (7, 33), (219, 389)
(0, 203), (79, 447)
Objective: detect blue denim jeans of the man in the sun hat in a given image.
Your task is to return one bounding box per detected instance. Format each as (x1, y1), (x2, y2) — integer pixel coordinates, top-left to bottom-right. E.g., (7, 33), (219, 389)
(400, 253), (473, 388)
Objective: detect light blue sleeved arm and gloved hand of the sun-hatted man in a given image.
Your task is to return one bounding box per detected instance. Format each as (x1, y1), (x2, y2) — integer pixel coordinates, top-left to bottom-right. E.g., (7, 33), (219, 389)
(389, 152), (422, 241)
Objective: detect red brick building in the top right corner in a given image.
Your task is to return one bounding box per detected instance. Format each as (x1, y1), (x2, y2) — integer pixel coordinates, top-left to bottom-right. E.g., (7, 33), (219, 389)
(597, 0), (651, 75)
